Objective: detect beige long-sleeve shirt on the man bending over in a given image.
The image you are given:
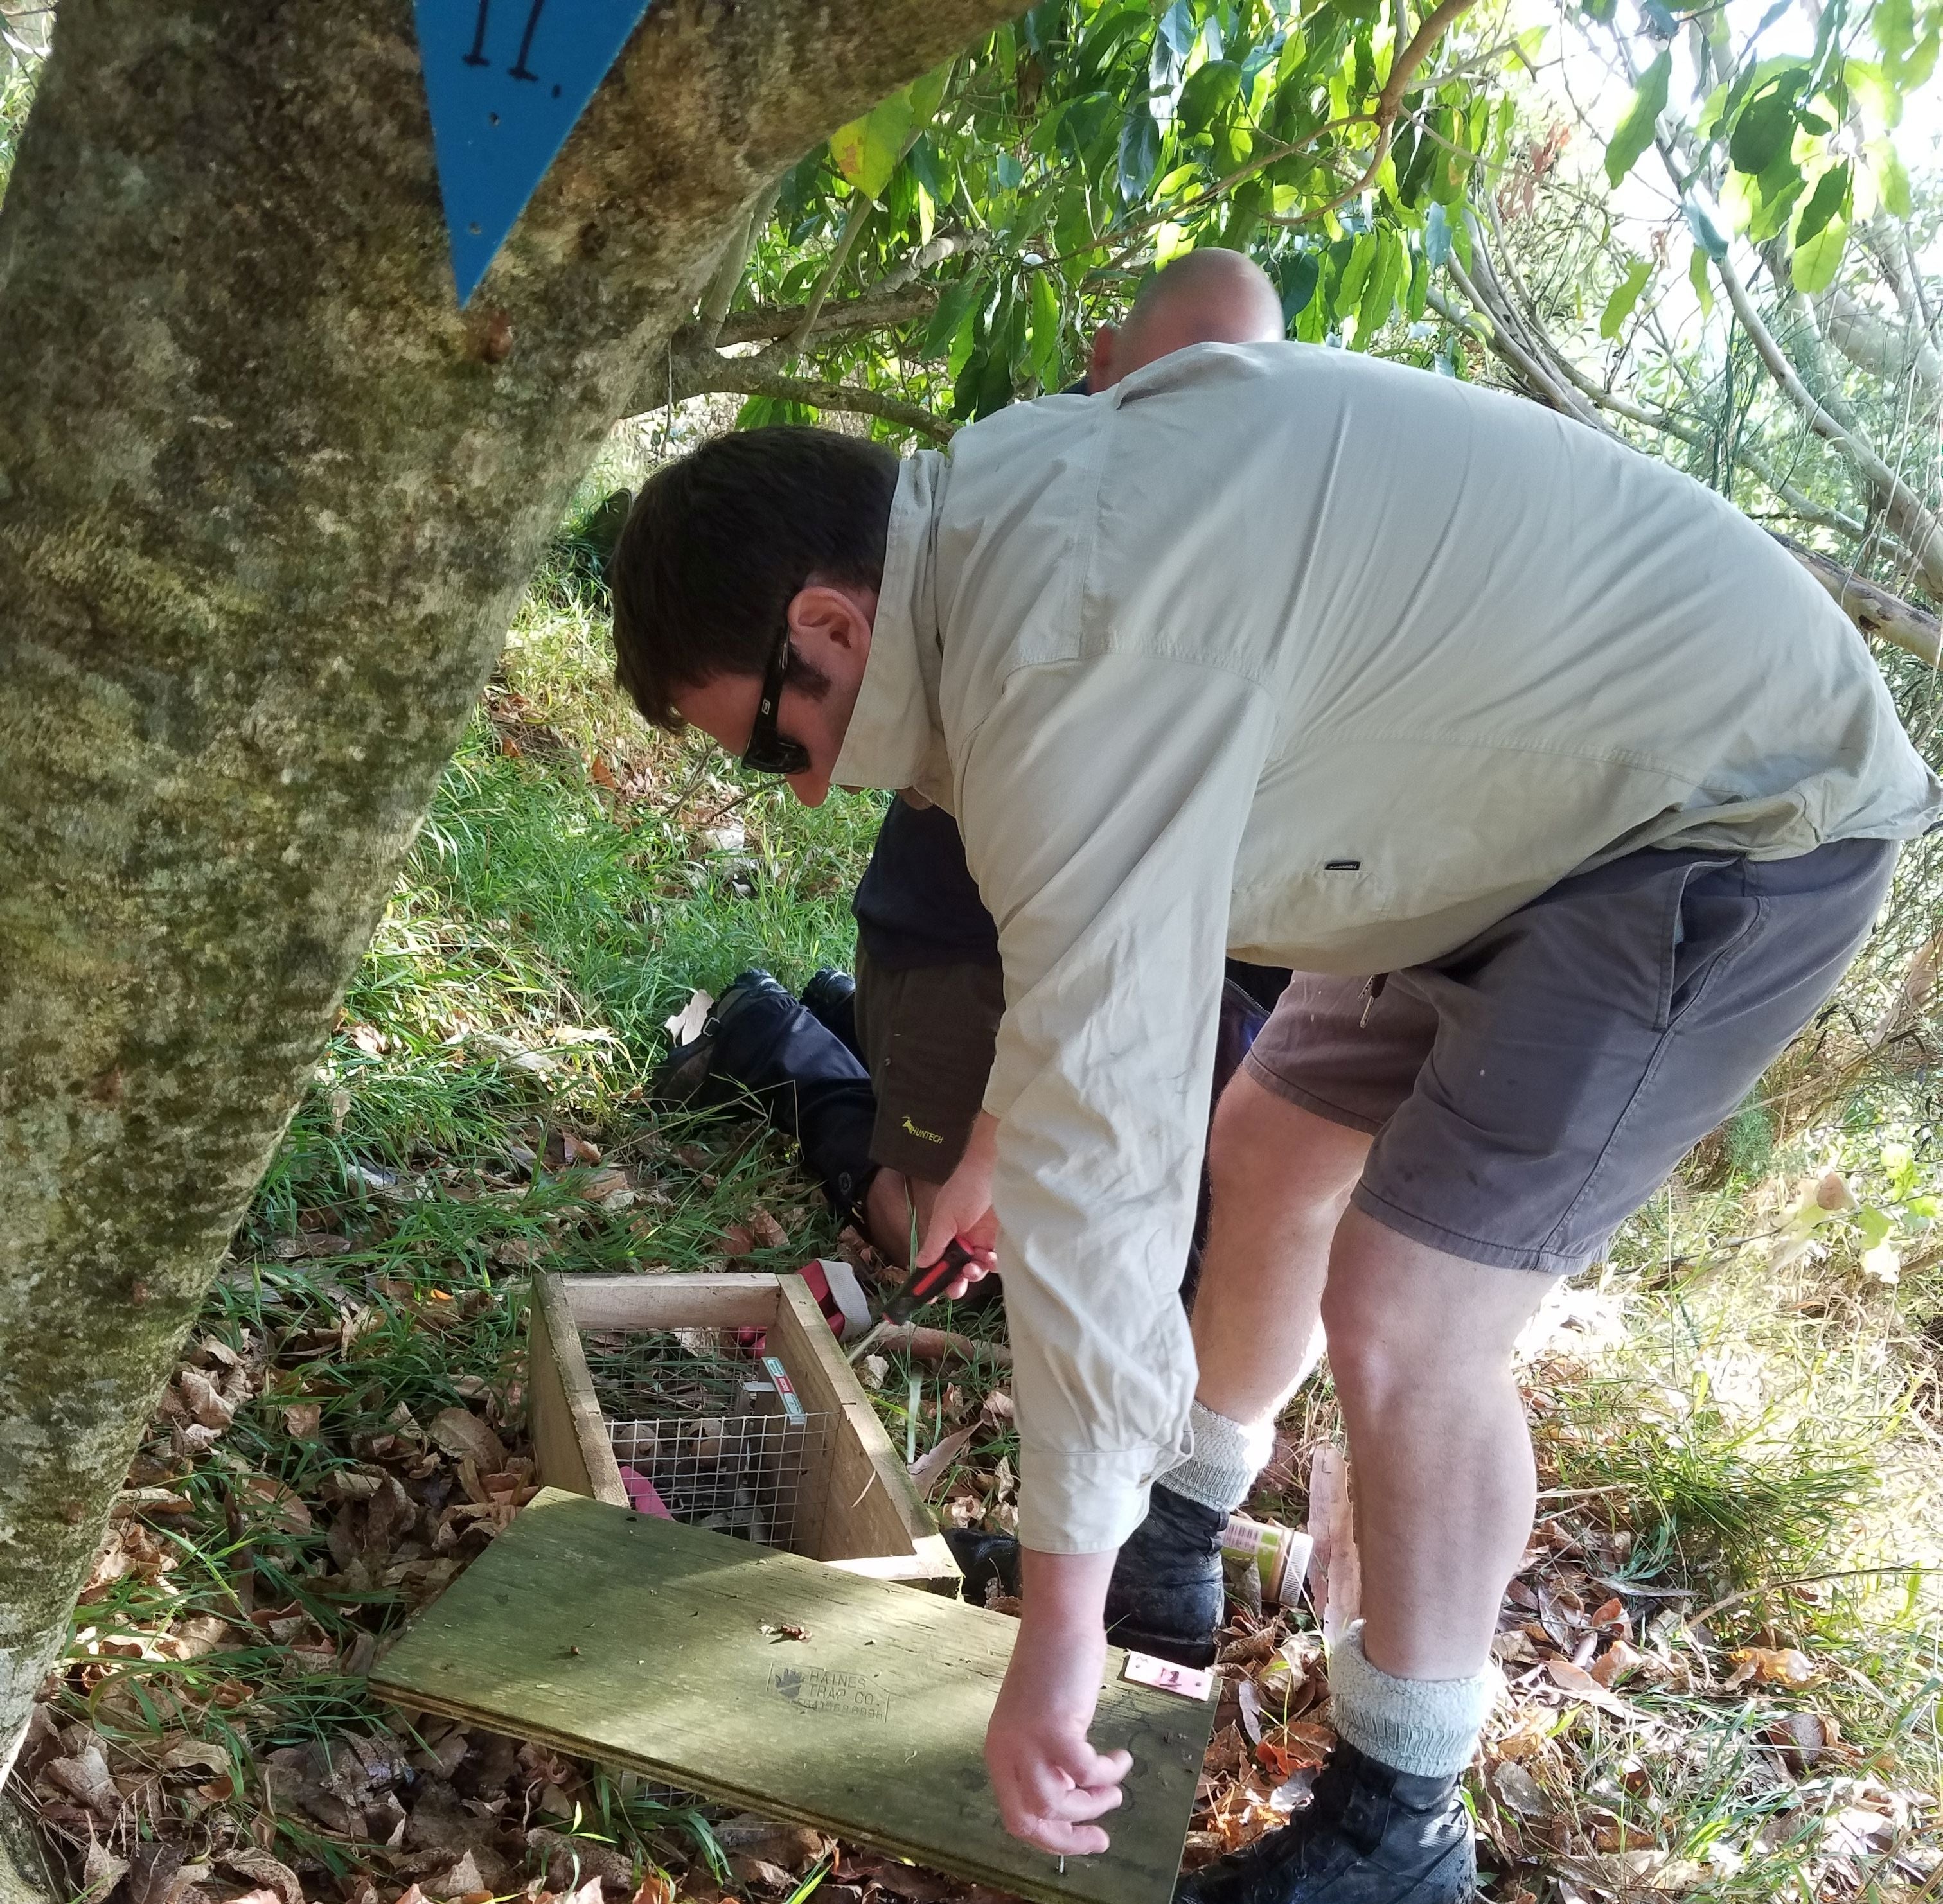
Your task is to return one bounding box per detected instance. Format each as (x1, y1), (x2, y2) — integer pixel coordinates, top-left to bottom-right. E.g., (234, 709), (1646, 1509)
(835, 344), (1943, 1553)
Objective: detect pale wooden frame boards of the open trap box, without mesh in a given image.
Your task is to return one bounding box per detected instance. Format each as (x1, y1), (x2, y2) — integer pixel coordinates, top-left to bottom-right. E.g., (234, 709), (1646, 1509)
(529, 1274), (960, 1595)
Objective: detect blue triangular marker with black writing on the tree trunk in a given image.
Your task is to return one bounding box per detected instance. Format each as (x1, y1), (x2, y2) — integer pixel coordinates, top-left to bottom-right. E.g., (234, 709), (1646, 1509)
(416, 0), (647, 305)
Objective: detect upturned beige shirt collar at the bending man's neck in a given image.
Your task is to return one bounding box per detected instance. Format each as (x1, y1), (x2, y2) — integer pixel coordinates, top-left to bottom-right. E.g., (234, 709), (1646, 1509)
(830, 449), (952, 806)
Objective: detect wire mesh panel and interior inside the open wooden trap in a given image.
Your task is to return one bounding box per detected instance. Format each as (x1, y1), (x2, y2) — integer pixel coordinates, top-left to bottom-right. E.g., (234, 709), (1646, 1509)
(583, 1329), (833, 1558)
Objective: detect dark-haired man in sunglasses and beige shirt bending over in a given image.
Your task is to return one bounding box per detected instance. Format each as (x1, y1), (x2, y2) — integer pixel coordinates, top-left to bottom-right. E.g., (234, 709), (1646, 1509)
(612, 344), (1943, 1904)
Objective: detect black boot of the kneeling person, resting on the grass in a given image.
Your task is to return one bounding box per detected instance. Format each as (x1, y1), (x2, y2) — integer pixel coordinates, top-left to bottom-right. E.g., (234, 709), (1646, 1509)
(649, 971), (876, 1218)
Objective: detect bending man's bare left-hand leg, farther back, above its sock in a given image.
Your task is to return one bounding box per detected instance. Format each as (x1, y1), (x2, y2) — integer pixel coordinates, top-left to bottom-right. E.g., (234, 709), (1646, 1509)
(1193, 1070), (1370, 1424)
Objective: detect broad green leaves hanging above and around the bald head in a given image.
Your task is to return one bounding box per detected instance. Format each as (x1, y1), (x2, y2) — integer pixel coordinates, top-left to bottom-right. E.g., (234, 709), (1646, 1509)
(742, 0), (1537, 427)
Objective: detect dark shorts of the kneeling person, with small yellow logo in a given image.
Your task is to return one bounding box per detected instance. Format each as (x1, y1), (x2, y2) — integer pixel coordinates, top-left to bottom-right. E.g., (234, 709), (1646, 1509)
(857, 946), (1004, 1183)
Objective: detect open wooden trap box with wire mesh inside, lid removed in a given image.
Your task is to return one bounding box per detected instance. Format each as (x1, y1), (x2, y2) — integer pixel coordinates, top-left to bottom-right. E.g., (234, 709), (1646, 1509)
(529, 1274), (960, 1595)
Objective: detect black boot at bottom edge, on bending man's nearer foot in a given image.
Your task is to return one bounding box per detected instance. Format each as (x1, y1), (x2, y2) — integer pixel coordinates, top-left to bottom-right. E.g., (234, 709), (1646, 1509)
(1173, 1741), (1477, 1904)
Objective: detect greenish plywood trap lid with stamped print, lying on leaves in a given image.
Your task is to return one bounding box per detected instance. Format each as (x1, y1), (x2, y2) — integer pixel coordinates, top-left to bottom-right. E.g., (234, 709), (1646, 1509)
(371, 1488), (1214, 1904)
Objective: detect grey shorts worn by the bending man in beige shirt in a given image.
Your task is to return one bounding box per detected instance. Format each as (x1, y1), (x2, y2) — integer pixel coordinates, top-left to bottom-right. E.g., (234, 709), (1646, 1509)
(1245, 840), (1896, 1276)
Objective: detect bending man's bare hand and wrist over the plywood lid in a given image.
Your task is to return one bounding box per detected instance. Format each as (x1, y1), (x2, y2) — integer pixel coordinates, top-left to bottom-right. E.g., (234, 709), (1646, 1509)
(985, 1549), (1133, 1857)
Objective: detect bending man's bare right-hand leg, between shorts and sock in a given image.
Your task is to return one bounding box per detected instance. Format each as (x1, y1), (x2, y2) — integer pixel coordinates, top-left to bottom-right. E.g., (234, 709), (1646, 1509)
(1323, 1210), (1552, 1680)
